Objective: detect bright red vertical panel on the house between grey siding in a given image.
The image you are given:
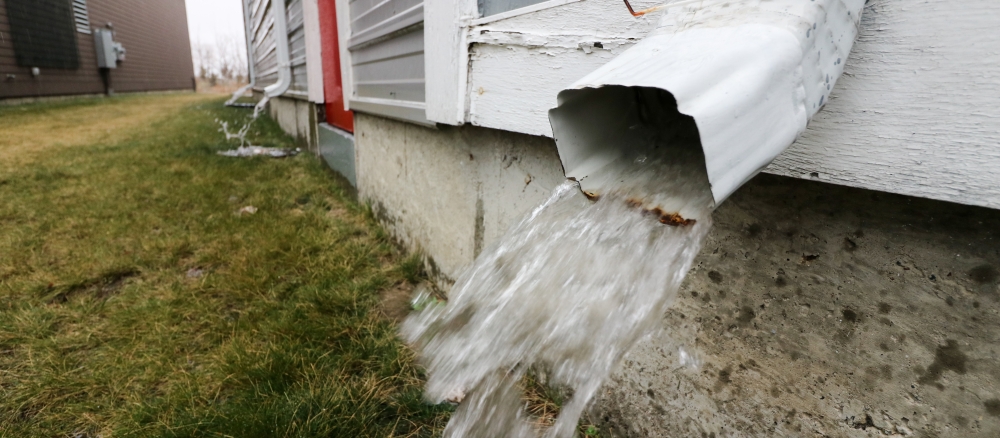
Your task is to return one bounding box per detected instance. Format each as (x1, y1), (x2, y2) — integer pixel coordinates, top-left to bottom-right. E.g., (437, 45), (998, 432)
(318, 0), (354, 132)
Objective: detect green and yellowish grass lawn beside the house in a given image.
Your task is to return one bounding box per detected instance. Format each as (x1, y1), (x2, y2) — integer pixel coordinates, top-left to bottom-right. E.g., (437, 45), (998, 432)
(0, 95), (450, 437)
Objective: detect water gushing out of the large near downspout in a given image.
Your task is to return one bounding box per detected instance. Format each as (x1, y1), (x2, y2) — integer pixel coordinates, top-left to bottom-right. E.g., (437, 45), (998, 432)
(403, 148), (712, 438)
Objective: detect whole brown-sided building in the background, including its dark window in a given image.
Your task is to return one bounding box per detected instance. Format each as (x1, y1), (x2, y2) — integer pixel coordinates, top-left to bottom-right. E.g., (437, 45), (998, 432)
(0, 0), (194, 99)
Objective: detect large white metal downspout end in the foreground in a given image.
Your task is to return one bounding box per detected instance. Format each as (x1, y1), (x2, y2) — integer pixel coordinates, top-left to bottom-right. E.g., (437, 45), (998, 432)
(549, 0), (865, 209)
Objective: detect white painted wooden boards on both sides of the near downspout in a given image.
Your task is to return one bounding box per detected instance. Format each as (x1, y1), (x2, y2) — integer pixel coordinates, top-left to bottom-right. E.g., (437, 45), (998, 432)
(458, 0), (1000, 208)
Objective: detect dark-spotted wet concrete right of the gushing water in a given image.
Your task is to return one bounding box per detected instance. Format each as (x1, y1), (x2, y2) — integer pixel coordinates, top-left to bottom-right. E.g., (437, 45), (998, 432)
(591, 175), (1000, 437)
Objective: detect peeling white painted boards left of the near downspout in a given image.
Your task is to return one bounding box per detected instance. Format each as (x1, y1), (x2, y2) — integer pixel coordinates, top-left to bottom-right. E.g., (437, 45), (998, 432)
(467, 0), (656, 137)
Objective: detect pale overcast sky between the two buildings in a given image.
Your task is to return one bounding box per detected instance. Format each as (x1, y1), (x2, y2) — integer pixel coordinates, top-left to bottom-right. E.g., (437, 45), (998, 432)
(185, 0), (246, 66)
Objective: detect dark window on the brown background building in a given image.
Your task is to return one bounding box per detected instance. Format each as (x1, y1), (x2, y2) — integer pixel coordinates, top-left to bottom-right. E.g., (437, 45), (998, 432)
(6, 0), (80, 69)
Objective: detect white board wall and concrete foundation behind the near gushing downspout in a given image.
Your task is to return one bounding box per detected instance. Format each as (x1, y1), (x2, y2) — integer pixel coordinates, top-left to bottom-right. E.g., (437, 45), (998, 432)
(294, 0), (1000, 437)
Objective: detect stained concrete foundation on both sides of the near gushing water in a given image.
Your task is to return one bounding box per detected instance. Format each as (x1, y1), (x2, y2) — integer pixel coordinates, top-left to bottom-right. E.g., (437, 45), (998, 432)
(355, 114), (1000, 437)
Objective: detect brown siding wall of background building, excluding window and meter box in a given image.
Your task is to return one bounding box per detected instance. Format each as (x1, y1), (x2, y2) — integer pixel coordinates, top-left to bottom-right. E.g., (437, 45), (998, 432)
(0, 0), (194, 99)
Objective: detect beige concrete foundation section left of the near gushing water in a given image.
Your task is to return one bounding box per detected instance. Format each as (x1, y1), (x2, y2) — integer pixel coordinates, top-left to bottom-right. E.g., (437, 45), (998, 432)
(354, 113), (564, 289)
